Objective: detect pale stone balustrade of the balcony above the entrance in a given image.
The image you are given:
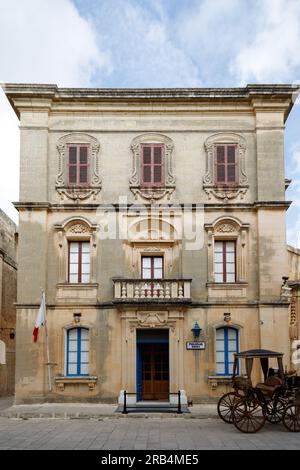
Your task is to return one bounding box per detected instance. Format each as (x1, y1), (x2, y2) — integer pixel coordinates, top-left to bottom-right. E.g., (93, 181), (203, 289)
(113, 278), (192, 303)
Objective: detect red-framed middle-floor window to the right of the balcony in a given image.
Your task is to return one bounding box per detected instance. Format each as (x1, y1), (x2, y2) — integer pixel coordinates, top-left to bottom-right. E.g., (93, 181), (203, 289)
(214, 240), (236, 282)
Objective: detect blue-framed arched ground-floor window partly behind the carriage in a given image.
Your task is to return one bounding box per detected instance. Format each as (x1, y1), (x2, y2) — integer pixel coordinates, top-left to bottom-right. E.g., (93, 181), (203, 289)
(216, 327), (239, 375)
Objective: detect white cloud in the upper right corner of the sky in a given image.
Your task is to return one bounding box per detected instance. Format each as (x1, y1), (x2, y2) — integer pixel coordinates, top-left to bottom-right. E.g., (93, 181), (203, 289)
(230, 0), (300, 84)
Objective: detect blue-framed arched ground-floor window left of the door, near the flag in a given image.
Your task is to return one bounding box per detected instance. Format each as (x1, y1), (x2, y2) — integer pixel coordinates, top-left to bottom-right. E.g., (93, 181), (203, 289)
(66, 328), (89, 376)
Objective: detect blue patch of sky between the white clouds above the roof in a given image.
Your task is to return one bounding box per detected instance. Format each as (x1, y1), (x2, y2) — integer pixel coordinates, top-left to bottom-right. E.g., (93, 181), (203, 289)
(83, 0), (201, 87)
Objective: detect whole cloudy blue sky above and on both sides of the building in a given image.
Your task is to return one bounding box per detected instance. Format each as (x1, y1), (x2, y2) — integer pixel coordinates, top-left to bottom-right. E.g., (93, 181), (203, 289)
(0, 0), (300, 247)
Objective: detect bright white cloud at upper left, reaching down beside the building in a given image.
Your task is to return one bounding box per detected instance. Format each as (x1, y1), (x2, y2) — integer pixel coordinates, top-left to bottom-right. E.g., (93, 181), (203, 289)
(0, 0), (111, 220)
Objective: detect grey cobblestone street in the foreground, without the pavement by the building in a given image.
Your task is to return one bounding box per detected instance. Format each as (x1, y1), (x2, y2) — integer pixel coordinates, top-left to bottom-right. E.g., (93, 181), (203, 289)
(0, 417), (300, 450)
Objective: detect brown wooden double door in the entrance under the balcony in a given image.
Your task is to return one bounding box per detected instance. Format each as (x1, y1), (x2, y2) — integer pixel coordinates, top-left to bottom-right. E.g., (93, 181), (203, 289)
(140, 343), (169, 401)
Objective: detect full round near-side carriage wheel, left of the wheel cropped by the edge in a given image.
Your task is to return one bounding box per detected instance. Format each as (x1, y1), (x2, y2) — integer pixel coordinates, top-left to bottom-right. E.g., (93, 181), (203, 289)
(232, 398), (266, 433)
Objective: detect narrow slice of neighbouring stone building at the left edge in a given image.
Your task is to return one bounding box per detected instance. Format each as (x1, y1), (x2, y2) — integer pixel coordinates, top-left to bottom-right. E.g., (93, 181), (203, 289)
(0, 209), (17, 395)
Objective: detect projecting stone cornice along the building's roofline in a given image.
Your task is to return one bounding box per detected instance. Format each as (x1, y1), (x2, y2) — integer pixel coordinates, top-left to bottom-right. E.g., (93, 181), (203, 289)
(2, 83), (299, 118)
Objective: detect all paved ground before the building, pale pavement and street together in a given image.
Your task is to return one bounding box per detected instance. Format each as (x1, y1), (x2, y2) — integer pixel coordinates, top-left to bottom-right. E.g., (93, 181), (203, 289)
(0, 397), (300, 451)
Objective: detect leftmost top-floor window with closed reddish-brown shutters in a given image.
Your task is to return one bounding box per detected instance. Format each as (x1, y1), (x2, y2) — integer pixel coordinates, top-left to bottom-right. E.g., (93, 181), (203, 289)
(68, 144), (89, 186)
